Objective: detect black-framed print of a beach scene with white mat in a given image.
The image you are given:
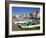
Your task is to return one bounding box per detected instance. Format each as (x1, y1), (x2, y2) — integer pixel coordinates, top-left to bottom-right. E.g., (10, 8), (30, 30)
(5, 1), (45, 37)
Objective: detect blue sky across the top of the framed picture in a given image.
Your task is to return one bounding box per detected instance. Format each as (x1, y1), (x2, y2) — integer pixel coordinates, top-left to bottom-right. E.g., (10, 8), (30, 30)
(12, 7), (40, 16)
